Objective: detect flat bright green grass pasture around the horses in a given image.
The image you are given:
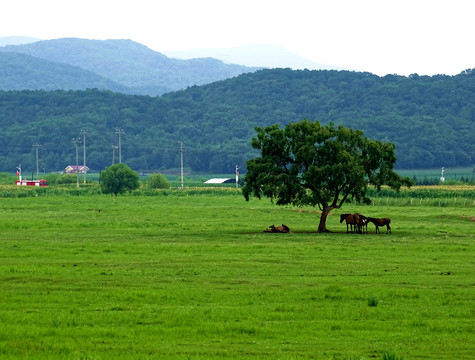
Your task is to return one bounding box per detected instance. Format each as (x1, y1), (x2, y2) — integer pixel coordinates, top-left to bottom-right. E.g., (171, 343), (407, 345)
(0, 187), (475, 360)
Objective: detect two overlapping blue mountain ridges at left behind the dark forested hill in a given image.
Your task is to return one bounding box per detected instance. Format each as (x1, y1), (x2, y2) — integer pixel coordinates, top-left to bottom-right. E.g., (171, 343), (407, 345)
(0, 38), (259, 96)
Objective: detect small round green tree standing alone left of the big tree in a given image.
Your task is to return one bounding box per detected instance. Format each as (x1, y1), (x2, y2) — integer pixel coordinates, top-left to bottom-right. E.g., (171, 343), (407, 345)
(100, 164), (140, 196)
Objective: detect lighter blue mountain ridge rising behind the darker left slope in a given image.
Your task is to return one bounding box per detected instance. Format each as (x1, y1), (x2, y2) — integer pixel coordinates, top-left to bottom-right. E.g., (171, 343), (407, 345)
(0, 38), (259, 96)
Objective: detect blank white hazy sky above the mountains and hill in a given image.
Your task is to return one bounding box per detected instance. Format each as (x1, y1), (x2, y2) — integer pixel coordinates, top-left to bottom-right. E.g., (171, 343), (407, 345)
(0, 0), (475, 75)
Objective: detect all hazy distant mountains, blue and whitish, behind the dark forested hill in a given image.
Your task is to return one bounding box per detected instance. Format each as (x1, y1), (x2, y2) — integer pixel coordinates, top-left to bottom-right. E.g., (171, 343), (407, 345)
(0, 36), (338, 96)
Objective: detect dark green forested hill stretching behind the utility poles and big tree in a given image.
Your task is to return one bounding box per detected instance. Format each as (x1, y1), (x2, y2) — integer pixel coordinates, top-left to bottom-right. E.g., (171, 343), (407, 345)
(0, 69), (475, 173)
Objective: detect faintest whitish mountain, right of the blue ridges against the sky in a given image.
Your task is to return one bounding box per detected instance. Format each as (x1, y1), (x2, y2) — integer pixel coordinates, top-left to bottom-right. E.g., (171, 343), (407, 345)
(163, 44), (347, 70)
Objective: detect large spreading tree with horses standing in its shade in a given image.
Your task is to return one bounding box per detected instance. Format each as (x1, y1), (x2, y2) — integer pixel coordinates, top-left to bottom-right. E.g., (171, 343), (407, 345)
(243, 120), (412, 232)
